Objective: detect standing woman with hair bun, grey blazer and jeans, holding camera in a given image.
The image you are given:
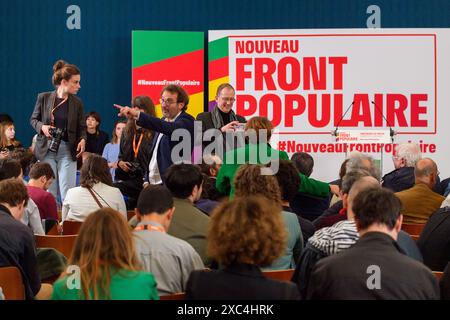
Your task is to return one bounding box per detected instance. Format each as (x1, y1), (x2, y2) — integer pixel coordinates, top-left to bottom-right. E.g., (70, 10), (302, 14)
(30, 60), (86, 202)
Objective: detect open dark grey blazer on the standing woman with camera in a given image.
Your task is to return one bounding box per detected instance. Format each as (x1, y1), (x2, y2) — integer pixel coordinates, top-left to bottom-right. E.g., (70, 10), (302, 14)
(30, 91), (86, 161)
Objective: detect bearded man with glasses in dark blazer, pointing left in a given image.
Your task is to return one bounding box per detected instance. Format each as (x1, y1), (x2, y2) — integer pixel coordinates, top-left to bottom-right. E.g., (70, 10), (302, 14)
(115, 85), (194, 184)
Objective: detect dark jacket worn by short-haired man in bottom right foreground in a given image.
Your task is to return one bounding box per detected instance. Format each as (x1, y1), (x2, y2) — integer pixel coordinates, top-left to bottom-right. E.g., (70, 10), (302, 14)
(307, 232), (439, 300)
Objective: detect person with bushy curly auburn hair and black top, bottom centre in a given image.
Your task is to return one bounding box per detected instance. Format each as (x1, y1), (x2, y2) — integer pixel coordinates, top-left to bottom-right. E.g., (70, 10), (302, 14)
(186, 196), (299, 300)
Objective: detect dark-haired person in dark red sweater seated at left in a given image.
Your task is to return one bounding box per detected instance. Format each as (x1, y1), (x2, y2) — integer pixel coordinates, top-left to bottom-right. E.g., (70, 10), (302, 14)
(27, 162), (58, 221)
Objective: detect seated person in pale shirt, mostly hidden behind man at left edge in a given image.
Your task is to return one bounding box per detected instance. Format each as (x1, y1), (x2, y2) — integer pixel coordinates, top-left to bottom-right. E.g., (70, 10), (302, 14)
(0, 157), (45, 235)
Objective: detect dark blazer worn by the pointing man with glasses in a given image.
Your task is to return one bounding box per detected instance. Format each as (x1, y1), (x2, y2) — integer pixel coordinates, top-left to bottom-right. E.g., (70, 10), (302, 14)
(136, 111), (194, 181)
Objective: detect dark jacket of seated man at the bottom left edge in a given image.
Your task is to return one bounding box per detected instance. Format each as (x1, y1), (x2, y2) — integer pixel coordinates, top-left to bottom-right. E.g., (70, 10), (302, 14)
(0, 206), (41, 299)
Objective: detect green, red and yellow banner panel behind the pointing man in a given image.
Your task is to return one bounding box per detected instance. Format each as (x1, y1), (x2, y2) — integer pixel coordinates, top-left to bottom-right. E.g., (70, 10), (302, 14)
(132, 31), (204, 117)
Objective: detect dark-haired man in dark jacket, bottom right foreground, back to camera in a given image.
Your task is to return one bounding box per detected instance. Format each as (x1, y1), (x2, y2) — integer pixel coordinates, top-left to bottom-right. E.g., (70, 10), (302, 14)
(307, 188), (439, 300)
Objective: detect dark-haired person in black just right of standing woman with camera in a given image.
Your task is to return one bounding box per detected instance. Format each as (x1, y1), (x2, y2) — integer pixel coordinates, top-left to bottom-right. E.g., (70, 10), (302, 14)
(85, 111), (109, 155)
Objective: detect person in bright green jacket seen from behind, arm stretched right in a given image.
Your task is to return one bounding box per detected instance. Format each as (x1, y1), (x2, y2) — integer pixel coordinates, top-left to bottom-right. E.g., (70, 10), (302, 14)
(216, 117), (337, 197)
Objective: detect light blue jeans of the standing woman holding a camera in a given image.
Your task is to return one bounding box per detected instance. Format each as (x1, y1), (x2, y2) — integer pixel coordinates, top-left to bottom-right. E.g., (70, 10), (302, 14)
(44, 141), (77, 203)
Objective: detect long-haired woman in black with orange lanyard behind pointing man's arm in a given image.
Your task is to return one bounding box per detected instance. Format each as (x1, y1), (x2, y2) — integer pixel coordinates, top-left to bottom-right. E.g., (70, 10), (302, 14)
(115, 96), (156, 210)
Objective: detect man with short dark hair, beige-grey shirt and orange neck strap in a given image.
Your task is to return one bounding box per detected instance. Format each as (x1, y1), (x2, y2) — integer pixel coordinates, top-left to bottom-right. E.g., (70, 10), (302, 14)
(134, 186), (205, 295)
